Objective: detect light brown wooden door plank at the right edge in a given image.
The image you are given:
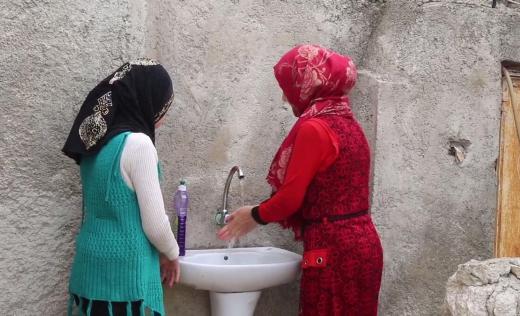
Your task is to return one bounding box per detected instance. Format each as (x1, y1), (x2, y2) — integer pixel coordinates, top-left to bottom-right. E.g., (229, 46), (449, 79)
(495, 78), (520, 257)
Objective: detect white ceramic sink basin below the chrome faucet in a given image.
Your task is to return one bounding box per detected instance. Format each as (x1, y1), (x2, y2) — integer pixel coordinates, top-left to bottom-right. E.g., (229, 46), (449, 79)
(180, 247), (302, 293)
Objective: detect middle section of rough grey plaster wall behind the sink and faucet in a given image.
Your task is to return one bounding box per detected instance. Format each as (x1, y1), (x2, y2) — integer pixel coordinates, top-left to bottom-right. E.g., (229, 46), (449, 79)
(147, 0), (379, 316)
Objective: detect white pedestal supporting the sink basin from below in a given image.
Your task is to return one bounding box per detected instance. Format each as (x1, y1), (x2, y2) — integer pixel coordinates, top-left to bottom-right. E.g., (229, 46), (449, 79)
(209, 291), (261, 316)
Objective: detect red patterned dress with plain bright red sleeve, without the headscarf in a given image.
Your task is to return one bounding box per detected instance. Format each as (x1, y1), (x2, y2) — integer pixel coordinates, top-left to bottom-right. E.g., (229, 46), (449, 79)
(259, 115), (383, 316)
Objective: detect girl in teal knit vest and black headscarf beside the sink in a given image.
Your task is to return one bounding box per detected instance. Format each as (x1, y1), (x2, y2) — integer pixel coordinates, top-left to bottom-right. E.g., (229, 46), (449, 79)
(63, 59), (180, 316)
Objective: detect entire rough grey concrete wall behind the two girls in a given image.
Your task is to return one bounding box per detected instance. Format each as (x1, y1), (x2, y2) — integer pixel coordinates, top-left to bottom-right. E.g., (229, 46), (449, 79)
(0, 0), (520, 316)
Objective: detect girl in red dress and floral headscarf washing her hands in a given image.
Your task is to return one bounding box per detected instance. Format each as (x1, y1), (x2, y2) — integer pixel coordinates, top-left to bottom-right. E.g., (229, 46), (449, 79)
(218, 45), (383, 316)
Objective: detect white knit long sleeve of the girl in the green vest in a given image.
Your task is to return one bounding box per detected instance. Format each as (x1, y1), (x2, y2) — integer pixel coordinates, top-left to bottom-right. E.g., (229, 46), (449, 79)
(120, 133), (179, 260)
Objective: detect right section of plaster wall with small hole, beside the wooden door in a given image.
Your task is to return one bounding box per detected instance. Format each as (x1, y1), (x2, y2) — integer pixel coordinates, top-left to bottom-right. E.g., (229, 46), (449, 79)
(364, 1), (520, 316)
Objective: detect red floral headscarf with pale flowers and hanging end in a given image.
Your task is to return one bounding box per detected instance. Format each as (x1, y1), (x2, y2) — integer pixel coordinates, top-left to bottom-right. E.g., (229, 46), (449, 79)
(267, 45), (357, 238)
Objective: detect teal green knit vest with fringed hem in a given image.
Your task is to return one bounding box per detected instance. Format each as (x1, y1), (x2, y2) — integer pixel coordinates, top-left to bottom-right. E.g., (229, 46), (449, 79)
(68, 132), (165, 316)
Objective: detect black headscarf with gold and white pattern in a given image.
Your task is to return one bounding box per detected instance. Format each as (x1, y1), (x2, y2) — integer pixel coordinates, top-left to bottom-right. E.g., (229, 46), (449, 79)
(62, 58), (173, 164)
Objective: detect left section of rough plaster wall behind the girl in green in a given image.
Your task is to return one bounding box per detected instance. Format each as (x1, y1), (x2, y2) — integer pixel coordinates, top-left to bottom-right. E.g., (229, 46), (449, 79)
(0, 0), (146, 316)
